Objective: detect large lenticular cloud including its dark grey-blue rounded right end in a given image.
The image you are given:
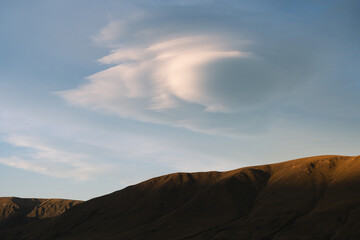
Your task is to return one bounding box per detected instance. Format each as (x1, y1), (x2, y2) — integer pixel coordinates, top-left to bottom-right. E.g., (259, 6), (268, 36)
(57, 29), (292, 137)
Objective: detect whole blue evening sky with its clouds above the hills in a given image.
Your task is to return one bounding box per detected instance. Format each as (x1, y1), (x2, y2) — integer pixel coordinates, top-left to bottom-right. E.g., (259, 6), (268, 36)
(0, 0), (360, 200)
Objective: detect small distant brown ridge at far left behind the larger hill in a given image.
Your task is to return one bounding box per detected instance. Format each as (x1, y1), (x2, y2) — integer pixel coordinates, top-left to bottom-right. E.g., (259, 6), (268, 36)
(0, 197), (81, 230)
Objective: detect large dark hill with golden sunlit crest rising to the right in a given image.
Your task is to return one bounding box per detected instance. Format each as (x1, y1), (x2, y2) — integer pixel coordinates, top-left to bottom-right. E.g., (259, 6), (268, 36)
(0, 156), (360, 240)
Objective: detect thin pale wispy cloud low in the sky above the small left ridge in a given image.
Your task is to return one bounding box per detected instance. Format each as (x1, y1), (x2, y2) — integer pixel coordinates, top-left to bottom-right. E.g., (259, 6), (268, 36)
(0, 135), (111, 181)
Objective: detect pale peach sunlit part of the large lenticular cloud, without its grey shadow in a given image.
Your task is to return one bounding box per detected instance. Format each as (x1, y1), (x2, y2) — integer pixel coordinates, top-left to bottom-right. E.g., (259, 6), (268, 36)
(59, 36), (251, 125)
